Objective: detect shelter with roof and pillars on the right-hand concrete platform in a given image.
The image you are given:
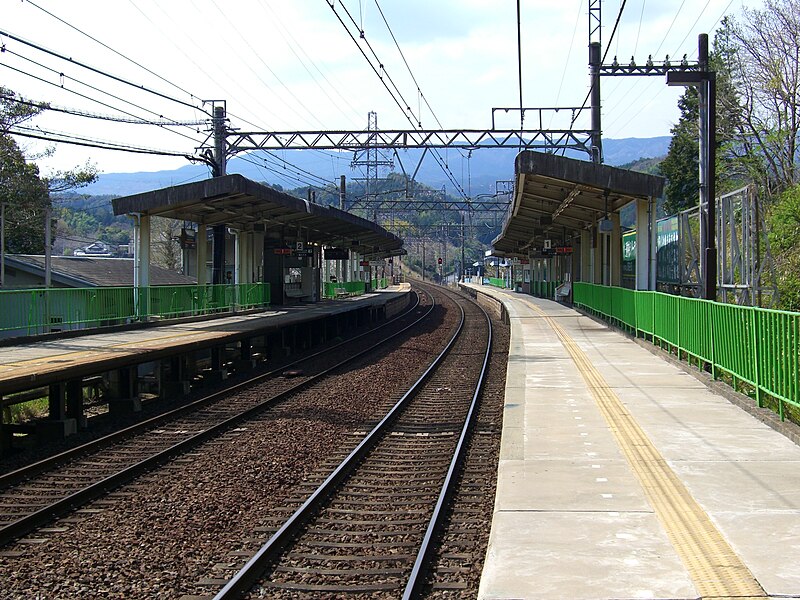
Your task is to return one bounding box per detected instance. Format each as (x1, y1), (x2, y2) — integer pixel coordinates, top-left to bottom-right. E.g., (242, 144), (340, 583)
(491, 151), (664, 297)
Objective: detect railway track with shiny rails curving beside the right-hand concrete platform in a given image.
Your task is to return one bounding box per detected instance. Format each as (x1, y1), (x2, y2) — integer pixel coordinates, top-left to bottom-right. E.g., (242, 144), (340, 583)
(216, 284), (492, 600)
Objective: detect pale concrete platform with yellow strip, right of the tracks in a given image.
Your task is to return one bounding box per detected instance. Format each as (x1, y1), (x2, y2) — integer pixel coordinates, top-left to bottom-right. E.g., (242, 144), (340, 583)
(465, 285), (800, 600)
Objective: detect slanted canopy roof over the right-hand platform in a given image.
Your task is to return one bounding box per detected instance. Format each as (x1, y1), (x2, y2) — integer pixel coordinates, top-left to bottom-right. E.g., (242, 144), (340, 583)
(492, 151), (664, 256)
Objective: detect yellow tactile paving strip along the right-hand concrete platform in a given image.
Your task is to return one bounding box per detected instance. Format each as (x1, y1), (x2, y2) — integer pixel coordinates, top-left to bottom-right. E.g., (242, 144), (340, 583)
(527, 303), (767, 600)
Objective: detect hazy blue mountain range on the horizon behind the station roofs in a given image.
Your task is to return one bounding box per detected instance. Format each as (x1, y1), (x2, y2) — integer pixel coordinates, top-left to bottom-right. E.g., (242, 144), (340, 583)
(81, 136), (671, 197)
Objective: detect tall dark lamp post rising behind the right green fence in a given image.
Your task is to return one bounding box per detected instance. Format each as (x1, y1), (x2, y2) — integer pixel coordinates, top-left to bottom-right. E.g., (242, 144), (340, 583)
(667, 33), (717, 300)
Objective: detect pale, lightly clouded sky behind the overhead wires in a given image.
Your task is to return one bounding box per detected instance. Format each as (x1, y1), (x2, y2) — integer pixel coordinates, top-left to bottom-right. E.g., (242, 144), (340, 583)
(0, 0), (757, 172)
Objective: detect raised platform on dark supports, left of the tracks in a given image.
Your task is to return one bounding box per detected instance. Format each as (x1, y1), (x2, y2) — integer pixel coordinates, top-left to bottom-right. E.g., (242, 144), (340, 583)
(0, 284), (410, 454)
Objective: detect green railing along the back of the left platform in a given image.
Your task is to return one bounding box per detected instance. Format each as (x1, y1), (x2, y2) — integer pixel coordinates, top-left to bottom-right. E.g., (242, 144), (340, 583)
(0, 283), (270, 337)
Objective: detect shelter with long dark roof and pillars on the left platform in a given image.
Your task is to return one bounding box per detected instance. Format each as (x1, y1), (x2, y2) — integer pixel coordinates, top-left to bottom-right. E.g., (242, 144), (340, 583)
(113, 175), (404, 304)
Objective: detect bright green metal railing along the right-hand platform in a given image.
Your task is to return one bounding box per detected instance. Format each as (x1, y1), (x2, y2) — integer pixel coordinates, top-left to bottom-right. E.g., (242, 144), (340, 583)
(573, 282), (800, 418)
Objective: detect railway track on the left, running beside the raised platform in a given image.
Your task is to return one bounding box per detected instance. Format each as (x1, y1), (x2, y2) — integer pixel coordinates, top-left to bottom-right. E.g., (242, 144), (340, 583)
(0, 288), (434, 546)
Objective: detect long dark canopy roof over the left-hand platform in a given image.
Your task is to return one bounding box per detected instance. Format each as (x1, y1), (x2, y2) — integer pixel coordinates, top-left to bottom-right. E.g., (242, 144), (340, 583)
(112, 175), (403, 256)
